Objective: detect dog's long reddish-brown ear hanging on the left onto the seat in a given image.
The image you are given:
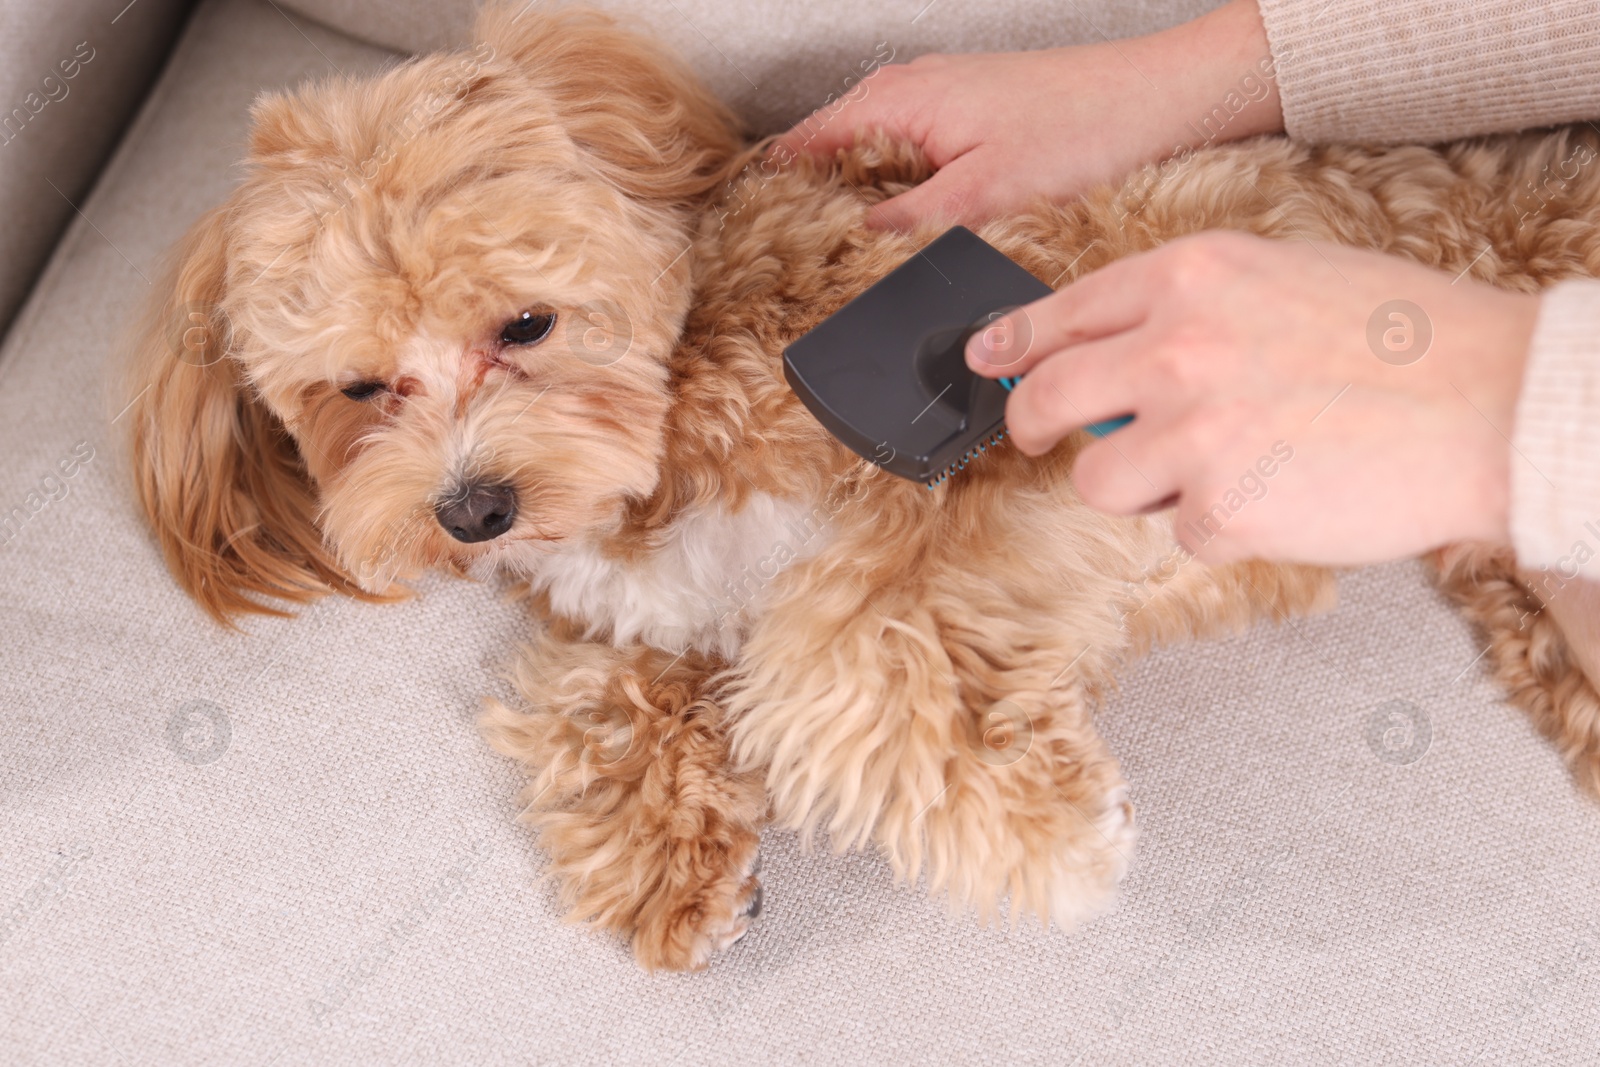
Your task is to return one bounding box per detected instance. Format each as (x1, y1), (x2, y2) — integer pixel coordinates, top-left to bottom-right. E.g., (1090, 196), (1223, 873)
(128, 206), (374, 625)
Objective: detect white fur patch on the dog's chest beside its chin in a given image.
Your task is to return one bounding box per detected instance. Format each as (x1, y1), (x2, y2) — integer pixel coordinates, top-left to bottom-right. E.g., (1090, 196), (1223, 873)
(515, 493), (832, 657)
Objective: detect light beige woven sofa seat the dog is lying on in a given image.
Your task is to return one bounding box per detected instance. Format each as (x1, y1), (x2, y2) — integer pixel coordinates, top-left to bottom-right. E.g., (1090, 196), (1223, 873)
(0, 0), (1600, 1067)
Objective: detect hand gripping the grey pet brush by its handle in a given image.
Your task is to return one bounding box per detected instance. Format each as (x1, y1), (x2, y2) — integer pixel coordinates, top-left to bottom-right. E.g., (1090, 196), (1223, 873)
(966, 232), (1539, 565)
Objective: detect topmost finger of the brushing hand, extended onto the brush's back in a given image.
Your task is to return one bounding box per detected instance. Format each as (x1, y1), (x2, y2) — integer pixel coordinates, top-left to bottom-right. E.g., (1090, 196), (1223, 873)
(966, 253), (1157, 379)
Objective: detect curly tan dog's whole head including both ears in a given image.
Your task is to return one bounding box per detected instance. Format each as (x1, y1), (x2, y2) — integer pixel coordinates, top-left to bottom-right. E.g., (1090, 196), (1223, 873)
(133, 5), (738, 621)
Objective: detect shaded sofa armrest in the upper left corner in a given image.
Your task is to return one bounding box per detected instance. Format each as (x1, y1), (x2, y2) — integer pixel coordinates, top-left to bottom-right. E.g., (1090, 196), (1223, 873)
(0, 0), (190, 331)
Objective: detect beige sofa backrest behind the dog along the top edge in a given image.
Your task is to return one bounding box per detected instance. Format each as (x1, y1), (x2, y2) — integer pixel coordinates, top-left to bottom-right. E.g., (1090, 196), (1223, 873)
(280, 0), (1221, 133)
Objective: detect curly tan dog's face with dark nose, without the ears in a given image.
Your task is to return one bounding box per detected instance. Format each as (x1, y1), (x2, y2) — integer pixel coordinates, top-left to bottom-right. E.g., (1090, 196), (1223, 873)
(235, 47), (688, 582)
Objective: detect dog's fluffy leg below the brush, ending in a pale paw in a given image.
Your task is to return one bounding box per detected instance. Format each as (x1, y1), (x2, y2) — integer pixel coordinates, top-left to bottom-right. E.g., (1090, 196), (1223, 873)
(728, 560), (1134, 926)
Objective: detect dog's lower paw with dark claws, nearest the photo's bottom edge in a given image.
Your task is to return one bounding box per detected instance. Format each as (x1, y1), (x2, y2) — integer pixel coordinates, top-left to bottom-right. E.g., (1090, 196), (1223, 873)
(634, 849), (763, 971)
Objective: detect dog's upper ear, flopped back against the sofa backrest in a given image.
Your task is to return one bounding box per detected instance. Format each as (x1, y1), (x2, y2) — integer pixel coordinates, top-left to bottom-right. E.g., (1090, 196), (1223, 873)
(475, 2), (739, 200)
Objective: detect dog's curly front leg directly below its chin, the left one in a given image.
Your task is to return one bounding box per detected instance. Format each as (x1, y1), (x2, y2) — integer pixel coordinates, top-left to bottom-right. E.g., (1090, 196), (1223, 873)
(483, 640), (766, 971)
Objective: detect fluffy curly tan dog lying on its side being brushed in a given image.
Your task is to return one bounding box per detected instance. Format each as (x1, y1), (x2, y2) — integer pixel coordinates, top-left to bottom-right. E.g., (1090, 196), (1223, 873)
(133, 10), (1600, 968)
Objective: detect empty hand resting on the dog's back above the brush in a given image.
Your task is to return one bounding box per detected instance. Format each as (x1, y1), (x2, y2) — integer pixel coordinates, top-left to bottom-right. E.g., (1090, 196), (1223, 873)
(771, 0), (1283, 229)
